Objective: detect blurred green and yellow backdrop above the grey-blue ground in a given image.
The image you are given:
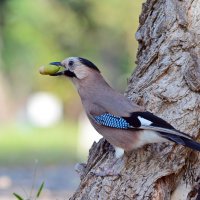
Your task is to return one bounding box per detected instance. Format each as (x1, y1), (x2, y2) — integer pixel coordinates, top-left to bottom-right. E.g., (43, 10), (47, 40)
(0, 0), (142, 198)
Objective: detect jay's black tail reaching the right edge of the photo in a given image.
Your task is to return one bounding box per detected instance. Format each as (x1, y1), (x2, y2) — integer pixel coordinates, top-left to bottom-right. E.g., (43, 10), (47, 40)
(160, 133), (200, 151)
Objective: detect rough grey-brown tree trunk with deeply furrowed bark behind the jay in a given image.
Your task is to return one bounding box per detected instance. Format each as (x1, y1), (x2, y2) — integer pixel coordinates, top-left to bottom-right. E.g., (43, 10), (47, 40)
(71, 0), (200, 200)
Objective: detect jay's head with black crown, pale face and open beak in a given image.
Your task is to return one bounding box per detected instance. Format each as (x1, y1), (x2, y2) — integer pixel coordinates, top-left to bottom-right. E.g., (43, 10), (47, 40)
(50, 57), (100, 80)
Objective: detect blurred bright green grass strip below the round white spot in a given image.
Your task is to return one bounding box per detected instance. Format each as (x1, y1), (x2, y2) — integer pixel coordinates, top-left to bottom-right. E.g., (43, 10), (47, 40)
(0, 122), (77, 166)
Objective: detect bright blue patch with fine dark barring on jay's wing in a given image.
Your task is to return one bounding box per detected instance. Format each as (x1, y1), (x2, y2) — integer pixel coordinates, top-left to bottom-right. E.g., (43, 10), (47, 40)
(94, 113), (131, 129)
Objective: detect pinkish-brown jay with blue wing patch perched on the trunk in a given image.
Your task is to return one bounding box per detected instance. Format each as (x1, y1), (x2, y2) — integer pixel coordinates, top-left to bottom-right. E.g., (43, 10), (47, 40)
(50, 57), (200, 176)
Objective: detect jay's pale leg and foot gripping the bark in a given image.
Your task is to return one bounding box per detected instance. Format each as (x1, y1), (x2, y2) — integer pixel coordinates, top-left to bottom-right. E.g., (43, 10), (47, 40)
(93, 147), (124, 177)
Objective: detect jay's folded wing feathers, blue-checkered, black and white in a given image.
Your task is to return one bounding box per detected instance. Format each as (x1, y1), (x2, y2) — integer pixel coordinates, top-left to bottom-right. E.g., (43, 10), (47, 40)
(92, 112), (192, 140)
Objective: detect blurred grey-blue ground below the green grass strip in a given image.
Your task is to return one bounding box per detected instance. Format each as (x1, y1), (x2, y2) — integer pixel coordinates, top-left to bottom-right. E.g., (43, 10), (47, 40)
(0, 165), (79, 200)
